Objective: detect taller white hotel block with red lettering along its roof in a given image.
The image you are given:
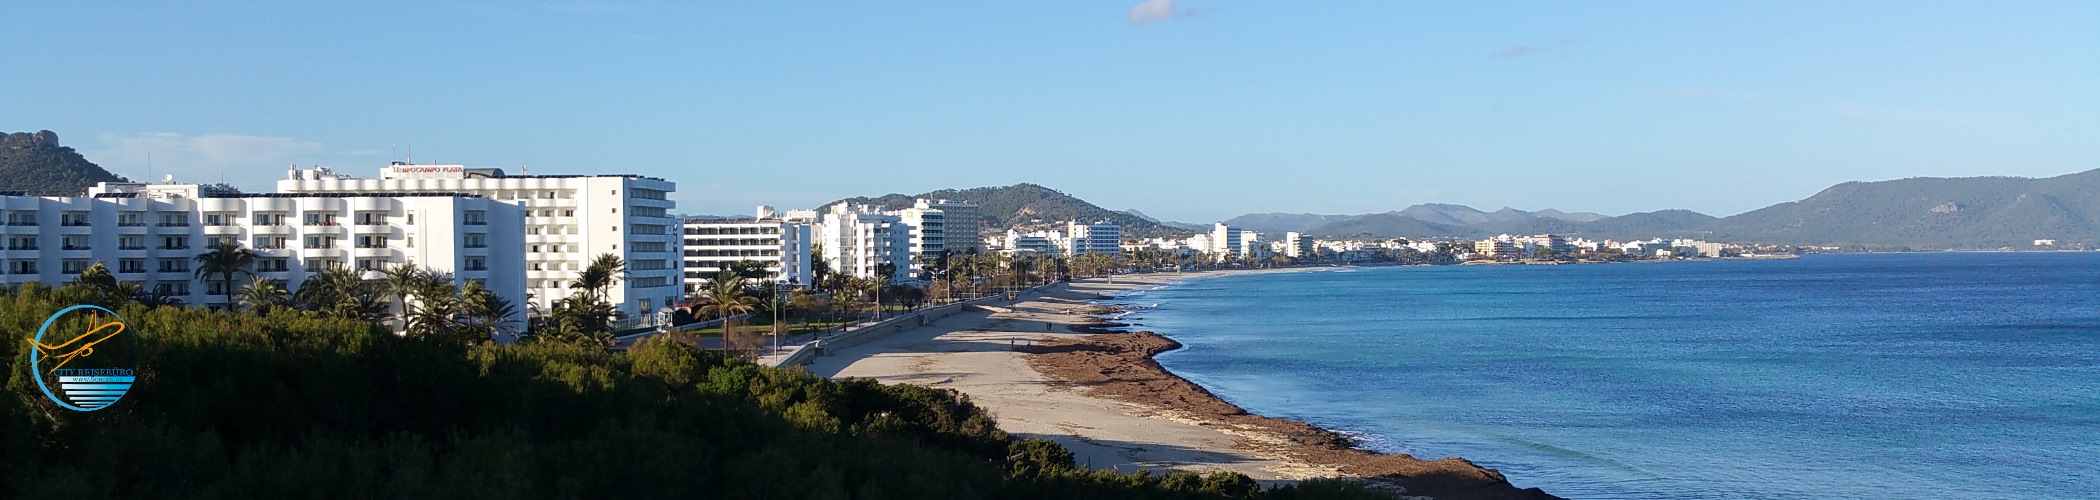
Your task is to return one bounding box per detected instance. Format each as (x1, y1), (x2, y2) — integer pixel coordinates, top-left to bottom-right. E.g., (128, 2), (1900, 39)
(277, 162), (685, 317)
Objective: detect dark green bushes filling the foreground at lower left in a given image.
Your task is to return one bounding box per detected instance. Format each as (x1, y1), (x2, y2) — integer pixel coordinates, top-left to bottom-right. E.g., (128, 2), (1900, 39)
(0, 284), (1394, 498)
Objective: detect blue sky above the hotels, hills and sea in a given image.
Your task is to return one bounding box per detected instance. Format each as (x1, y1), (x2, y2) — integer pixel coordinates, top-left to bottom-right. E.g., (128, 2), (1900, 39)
(0, 0), (2100, 223)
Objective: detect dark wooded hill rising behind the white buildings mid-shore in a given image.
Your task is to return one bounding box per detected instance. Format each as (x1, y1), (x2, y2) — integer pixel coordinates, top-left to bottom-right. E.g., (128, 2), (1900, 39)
(819, 183), (1191, 237)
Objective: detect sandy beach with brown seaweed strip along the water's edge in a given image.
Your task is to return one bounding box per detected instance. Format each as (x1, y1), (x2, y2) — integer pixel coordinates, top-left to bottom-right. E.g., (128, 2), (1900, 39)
(806, 269), (1552, 498)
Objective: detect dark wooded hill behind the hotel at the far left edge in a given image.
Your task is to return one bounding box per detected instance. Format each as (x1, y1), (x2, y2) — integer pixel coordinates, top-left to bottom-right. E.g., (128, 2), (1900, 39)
(0, 130), (126, 195)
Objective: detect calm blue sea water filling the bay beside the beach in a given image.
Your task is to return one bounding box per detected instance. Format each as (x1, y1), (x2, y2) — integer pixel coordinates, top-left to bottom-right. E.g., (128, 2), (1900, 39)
(1117, 252), (2100, 498)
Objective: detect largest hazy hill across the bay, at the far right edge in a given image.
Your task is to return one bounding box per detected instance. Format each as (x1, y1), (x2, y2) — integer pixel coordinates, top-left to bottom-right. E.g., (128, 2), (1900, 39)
(1705, 170), (2100, 248)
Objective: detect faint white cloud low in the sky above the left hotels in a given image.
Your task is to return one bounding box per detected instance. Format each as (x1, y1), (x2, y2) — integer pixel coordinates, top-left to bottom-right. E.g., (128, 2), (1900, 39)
(80, 132), (384, 193)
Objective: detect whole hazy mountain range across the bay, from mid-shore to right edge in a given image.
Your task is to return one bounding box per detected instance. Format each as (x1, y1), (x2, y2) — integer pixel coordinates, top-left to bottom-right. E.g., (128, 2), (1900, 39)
(1224, 170), (2100, 248)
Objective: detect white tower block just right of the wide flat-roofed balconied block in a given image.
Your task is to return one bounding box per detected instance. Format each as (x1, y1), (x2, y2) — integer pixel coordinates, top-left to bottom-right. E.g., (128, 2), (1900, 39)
(813, 204), (911, 279)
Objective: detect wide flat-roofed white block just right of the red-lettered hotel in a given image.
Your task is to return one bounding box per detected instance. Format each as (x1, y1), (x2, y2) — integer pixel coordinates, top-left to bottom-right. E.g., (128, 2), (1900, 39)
(685, 206), (813, 292)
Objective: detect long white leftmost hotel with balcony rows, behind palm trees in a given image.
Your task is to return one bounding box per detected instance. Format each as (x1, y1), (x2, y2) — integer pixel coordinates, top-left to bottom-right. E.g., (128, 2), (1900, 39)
(0, 183), (525, 321)
